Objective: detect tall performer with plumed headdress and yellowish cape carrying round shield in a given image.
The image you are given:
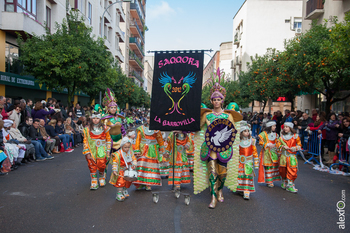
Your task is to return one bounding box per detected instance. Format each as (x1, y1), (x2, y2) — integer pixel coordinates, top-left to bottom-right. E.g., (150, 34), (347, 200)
(194, 69), (243, 209)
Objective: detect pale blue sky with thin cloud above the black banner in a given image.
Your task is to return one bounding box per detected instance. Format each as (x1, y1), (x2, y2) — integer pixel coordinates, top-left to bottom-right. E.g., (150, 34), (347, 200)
(146, 0), (244, 63)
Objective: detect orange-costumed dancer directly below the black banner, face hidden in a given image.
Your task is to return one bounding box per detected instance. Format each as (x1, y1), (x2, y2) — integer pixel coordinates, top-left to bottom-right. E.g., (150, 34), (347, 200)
(164, 131), (192, 189)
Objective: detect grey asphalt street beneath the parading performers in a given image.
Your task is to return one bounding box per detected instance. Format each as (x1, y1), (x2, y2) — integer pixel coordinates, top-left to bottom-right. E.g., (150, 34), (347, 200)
(0, 147), (350, 233)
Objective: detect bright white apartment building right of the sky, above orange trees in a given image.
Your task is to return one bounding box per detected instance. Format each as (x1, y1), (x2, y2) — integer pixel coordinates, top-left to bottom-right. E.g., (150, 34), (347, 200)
(231, 0), (303, 112)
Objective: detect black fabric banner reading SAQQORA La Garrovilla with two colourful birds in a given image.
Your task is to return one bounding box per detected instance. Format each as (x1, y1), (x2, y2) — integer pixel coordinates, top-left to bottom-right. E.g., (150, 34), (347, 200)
(150, 51), (204, 131)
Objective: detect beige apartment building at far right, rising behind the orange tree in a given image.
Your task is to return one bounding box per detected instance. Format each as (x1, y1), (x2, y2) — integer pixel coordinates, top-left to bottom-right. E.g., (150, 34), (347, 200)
(297, 0), (350, 112)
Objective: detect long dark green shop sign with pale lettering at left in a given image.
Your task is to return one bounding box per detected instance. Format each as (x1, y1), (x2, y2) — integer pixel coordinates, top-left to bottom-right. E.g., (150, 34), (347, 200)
(0, 72), (89, 97)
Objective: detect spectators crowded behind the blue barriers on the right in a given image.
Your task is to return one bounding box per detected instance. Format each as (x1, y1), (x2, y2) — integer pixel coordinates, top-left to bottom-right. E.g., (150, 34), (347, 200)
(243, 109), (350, 170)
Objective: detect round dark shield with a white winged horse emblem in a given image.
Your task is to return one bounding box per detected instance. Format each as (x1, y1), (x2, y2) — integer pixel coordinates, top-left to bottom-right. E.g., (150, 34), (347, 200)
(205, 119), (237, 152)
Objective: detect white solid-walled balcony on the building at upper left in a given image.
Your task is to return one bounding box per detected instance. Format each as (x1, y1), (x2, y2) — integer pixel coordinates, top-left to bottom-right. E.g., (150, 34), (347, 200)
(1, 11), (46, 36)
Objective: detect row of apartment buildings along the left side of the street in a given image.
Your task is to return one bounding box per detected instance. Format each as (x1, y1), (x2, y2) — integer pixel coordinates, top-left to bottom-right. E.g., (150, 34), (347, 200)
(0, 0), (137, 103)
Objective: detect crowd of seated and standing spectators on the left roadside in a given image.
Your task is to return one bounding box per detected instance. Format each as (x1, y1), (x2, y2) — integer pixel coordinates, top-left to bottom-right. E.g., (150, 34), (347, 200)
(0, 96), (147, 174)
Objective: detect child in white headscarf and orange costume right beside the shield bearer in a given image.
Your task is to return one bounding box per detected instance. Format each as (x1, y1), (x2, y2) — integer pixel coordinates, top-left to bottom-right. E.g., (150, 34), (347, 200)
(237, 122), (259, 200)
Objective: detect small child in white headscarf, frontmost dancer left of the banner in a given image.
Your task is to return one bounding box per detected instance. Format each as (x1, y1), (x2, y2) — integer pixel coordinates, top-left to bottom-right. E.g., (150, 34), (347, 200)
(109, 137), (137, 201)
